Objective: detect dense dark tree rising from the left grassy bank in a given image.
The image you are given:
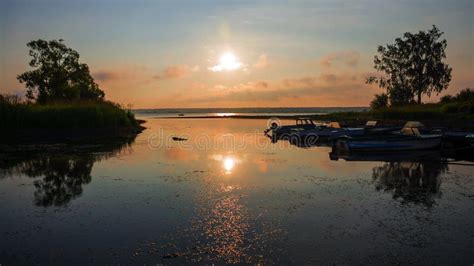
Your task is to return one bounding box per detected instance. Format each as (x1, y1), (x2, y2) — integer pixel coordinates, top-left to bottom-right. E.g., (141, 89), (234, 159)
(17, 39), (105, 103)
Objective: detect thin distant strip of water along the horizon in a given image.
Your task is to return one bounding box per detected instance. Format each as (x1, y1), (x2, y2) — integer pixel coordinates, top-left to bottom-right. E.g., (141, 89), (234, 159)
(134, 107), (369, 117)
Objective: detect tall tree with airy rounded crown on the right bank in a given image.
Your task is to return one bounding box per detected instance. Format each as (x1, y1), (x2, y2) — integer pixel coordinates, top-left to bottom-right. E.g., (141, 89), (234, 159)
(367, 25), (452, 104)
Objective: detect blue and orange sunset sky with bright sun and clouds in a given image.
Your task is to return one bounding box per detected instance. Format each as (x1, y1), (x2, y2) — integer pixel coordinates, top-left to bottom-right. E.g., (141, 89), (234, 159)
(0, 0), (474, 108)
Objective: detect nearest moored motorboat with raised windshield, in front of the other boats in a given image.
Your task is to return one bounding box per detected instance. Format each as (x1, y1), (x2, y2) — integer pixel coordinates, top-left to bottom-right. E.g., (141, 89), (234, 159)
(334, 122), (442, 152)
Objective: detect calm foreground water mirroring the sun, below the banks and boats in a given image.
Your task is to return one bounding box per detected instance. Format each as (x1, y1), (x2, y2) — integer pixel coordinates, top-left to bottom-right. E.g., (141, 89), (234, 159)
(0, 118), (474, 265)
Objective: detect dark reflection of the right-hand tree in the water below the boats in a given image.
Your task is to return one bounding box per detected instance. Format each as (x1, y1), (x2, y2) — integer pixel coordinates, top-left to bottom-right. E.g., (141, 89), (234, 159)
(372, 161), (448, 207)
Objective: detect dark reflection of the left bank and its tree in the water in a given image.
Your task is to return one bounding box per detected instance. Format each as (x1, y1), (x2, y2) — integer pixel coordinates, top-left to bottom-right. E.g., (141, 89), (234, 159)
(0, 137), (134, 207)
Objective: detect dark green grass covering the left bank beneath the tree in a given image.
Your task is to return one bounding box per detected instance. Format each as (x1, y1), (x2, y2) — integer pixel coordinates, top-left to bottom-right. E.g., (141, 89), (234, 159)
(0, 100), (138, 129)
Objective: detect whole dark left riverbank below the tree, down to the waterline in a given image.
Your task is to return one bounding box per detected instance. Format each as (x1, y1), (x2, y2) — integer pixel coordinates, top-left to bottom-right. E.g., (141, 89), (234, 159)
(0, 101), (144, 143)
